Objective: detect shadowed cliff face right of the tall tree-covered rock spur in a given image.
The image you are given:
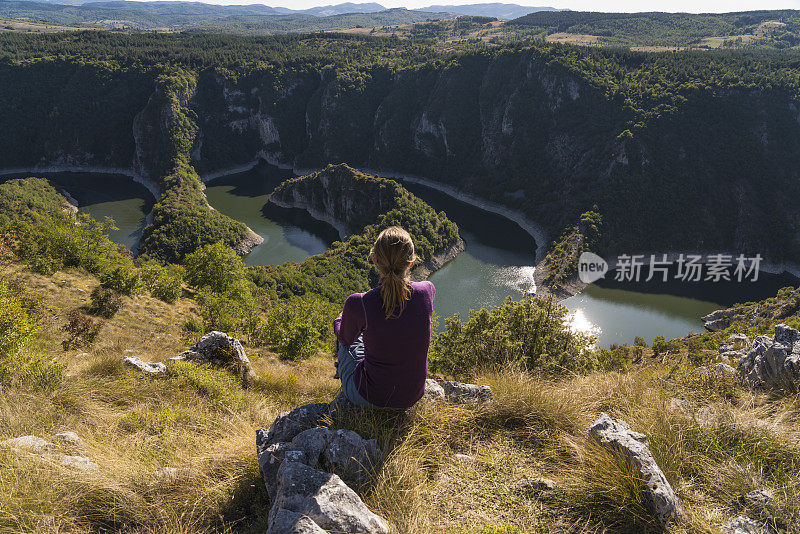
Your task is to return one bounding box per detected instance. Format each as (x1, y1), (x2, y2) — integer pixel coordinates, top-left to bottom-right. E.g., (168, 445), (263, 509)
(195, 51), (800, 260)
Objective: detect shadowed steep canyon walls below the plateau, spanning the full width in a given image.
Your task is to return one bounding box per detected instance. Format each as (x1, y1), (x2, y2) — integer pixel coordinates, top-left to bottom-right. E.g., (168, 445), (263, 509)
(0, 47), (800, 261)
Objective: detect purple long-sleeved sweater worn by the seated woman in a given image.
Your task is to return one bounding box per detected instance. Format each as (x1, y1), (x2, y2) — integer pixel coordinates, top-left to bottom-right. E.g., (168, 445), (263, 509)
(333, 282), (436, 408)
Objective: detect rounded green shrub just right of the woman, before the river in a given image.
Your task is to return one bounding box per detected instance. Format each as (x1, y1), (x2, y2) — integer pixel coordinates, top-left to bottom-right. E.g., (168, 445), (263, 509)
(429, 296), (598, 377)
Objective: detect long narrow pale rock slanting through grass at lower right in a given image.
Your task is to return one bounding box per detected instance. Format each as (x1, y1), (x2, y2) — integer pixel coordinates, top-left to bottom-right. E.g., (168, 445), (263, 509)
(589, 413), (683, 525)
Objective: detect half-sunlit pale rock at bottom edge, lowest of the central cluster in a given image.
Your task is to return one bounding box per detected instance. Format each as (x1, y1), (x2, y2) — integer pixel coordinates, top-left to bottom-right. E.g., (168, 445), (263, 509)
(269, 461), (389, 534)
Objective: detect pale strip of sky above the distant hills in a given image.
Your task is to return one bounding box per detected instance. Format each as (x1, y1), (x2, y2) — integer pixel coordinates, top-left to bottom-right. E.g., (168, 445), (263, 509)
(220, 0), (800, 13)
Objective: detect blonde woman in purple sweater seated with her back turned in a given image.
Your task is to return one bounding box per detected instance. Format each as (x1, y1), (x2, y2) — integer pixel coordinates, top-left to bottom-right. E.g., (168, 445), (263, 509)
(333, 226), (436, 408)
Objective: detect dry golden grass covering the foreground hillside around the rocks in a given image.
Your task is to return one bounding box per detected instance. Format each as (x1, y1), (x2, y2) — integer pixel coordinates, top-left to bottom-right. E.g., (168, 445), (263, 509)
(0, 266), (800, 534)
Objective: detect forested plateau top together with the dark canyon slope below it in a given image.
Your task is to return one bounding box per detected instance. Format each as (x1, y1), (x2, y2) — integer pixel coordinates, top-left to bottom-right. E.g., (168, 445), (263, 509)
(0, 33), (800, 260)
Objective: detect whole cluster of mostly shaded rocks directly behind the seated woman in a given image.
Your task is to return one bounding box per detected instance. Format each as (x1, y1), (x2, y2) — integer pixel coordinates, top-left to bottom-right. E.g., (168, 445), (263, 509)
(256, 404), (389, 534)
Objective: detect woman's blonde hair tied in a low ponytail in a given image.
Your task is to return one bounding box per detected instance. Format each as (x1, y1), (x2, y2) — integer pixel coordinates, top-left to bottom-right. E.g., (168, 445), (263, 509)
(370, 226), (417, 319)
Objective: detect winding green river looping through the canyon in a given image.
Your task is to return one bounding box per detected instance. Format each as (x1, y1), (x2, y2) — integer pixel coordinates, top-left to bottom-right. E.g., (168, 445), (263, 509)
(7, 169), (798, 347)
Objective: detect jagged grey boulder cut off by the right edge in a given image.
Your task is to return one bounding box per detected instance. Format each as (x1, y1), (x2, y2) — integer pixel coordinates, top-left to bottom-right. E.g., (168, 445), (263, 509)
(736, 324), (800, 391)
